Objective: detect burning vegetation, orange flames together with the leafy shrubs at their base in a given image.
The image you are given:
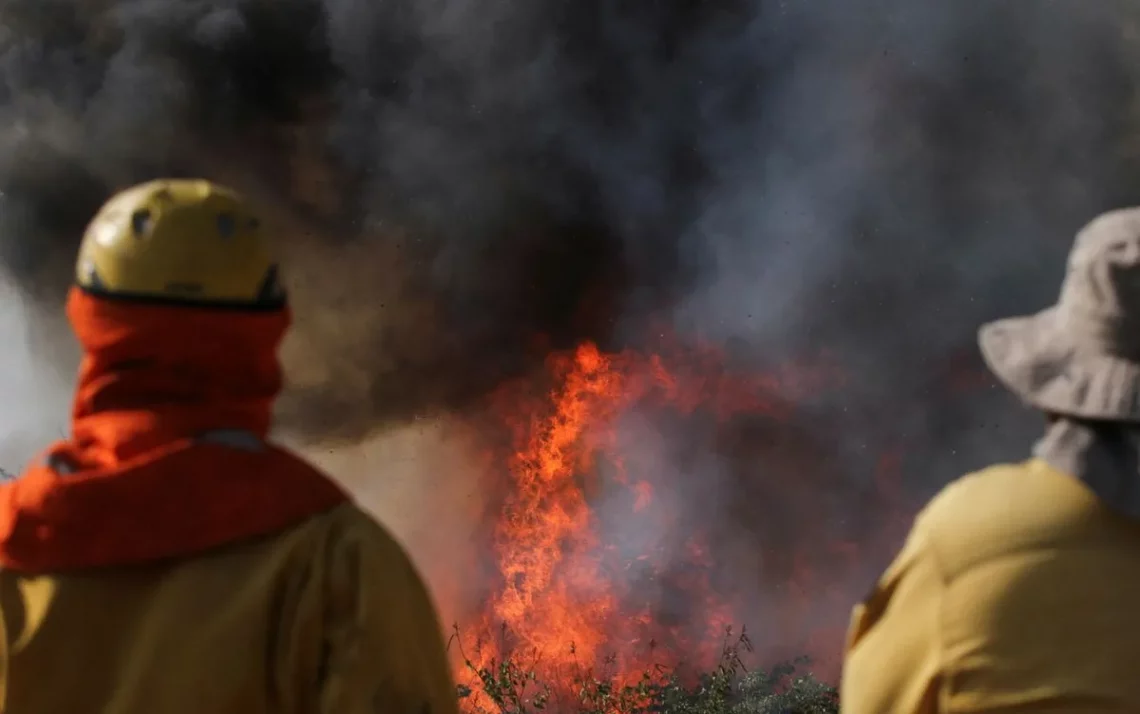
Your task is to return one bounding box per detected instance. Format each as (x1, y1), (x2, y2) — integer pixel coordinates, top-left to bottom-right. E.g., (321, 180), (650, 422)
(440, 340), (866, 714)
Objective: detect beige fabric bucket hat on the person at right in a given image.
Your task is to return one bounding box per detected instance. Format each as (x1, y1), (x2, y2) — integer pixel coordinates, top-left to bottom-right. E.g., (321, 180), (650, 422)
(978, 208), (1140, 422)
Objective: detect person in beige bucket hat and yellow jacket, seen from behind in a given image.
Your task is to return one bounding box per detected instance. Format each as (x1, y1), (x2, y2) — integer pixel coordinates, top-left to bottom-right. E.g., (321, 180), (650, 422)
(840, 208), (1140, 714)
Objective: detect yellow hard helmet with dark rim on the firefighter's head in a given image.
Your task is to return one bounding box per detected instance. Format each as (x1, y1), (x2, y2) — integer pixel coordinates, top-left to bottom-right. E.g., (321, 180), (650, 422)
(75, 179), (285, 308)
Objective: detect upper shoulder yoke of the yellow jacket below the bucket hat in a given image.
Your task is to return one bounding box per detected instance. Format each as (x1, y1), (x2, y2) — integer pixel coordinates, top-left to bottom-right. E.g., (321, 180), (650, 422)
(914, 460), (1122, 579)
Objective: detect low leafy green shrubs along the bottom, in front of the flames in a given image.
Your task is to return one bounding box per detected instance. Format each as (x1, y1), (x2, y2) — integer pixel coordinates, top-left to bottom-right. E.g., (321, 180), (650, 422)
(453, 631), (839, 714)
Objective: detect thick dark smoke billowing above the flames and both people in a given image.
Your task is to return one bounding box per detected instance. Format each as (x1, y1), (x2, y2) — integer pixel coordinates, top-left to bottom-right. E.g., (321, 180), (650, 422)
(0, 0), (1140, 670)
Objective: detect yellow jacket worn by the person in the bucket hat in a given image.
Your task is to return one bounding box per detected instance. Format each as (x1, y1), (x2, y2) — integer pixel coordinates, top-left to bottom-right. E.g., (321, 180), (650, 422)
(840, 460), (1140, 714)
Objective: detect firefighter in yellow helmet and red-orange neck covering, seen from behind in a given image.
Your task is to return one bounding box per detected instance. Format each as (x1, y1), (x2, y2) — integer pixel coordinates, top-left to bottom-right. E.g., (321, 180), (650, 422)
(0, 180), (457, 714)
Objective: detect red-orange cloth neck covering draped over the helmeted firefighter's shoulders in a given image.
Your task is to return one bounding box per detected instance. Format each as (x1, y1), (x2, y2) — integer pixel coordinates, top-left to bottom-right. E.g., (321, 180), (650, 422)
(0, 289), (347, 571)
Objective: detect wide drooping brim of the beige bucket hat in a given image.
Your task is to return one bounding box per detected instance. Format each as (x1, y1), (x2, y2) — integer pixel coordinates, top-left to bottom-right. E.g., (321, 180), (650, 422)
(978, 307), (1140, 422)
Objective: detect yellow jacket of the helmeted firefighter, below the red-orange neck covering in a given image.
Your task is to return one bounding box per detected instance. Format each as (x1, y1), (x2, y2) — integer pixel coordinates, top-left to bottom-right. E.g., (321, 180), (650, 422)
(0, 504), (457, 714)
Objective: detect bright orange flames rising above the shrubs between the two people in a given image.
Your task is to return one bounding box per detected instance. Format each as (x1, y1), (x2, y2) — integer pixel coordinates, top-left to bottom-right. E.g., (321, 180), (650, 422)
(458, 335), (839, 707)
